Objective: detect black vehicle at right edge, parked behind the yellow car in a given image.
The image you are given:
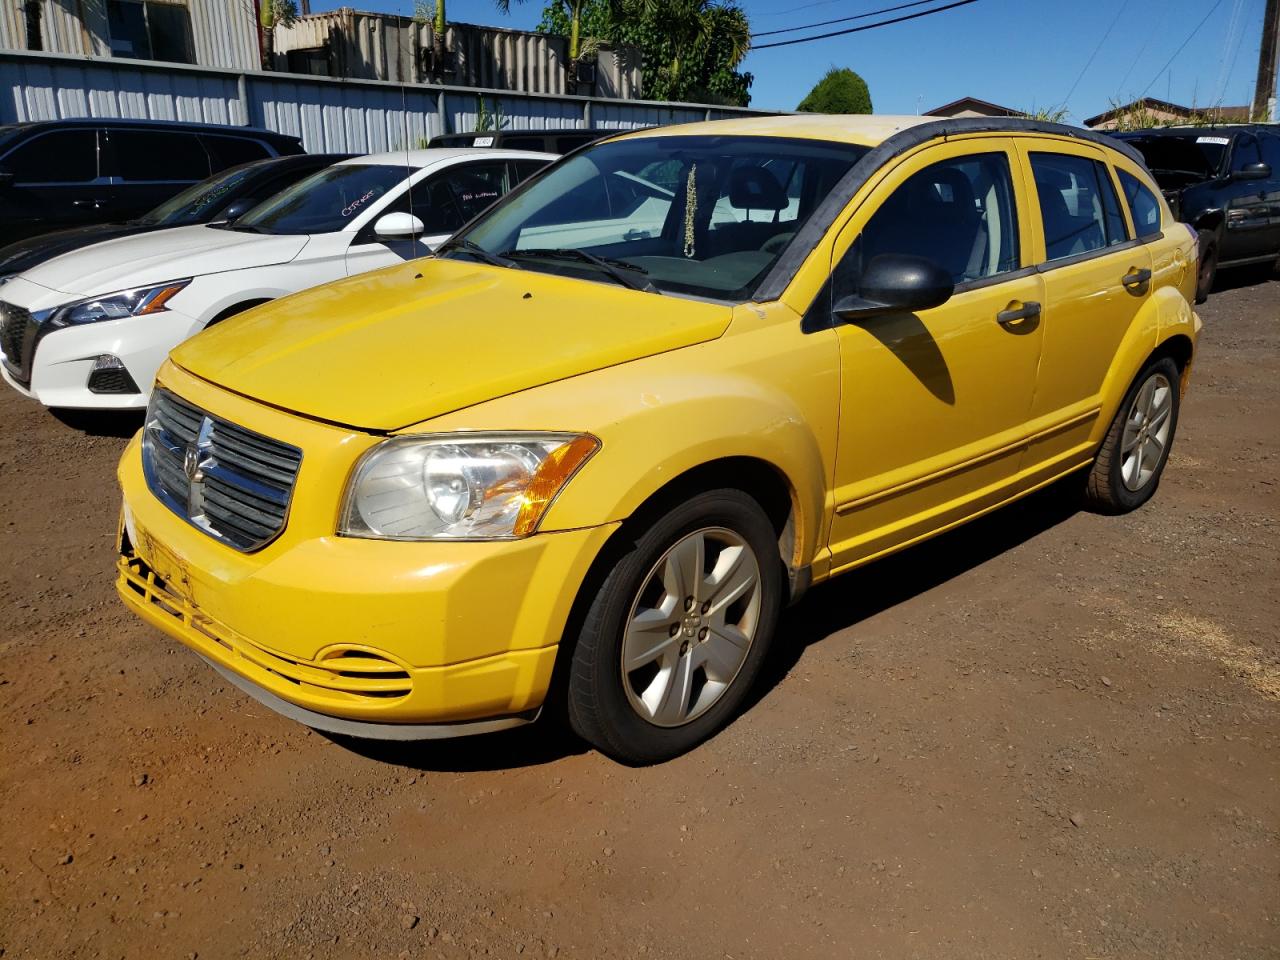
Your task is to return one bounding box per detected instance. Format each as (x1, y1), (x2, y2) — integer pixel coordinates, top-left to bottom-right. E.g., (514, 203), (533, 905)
(1112, 123), (1280, 303)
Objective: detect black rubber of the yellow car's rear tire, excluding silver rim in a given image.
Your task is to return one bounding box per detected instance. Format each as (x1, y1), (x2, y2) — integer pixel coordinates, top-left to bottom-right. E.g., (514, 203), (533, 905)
(1084, 357), (1181, 513)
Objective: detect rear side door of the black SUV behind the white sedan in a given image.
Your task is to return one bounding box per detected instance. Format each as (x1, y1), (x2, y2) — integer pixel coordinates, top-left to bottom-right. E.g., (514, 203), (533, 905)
(102, 127), (210, 219)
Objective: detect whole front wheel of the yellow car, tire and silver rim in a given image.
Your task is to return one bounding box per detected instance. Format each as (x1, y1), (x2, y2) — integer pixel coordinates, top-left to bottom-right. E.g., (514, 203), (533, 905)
(568, 489), (786, 765)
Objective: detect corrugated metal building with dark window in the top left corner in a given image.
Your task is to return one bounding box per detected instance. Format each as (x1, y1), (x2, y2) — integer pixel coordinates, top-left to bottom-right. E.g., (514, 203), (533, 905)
(0, 0), (259, 70)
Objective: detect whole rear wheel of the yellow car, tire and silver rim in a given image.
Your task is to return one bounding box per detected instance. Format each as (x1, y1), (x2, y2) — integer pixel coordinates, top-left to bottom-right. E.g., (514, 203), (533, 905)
(1085, 357), (1181, 513)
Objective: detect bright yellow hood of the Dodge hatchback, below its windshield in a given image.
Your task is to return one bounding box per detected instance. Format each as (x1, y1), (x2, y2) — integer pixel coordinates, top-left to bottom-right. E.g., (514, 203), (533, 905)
(172, 259), (732, 430)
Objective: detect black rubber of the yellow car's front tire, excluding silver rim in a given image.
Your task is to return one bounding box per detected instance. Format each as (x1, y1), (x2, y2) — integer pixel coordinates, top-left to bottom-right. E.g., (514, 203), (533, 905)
(567, 489), (786, 765)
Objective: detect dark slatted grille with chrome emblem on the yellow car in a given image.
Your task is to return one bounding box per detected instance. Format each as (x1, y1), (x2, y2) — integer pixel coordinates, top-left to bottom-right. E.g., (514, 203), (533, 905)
(142, 388), (302, 550)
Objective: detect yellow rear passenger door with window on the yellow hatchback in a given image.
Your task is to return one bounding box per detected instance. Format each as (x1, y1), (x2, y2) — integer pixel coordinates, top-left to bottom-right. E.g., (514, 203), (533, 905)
(1019, 138), (1152, 472)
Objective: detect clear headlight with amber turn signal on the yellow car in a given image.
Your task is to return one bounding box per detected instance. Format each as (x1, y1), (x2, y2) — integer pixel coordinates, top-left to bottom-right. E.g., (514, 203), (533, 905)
(338, 433), (600, 540)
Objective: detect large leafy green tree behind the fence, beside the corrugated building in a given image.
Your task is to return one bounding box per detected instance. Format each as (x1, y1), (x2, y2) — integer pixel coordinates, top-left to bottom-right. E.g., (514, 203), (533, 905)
(538, 0), (753, 106)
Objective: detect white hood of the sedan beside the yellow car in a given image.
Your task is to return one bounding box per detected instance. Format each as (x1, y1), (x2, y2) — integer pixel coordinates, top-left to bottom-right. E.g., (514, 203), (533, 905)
(23, 224), (307, 297)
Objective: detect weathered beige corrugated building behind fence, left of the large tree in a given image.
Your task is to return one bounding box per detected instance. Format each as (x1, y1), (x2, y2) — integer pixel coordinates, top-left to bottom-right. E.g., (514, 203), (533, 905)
(275, 8), (641, 99)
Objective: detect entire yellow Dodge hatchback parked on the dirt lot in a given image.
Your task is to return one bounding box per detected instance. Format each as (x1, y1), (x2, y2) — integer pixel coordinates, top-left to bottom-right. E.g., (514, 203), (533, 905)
(118, 116), (1199, 763)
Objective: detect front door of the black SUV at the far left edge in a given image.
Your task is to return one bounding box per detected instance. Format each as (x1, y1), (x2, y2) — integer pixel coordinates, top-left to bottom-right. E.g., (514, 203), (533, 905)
(0, 127), (108, 242)
